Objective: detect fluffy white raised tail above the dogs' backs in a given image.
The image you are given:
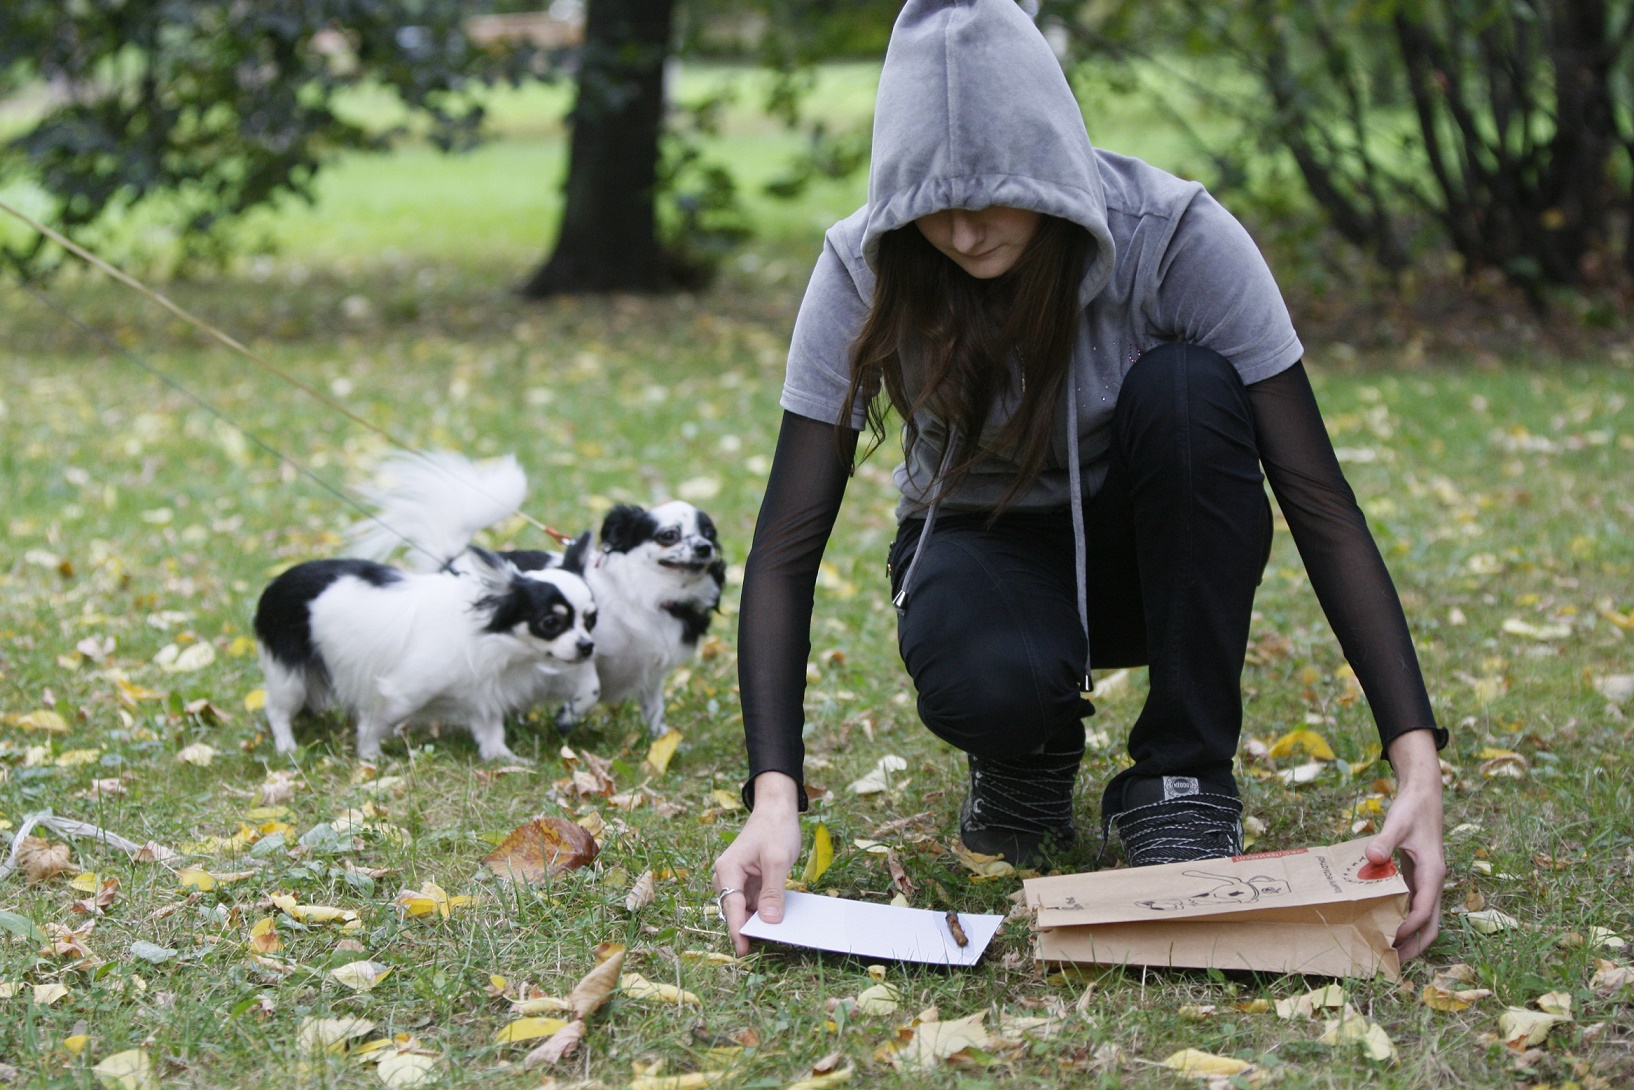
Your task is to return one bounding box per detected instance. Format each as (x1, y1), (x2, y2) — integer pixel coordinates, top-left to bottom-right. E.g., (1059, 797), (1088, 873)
(348, 451), (528, 572)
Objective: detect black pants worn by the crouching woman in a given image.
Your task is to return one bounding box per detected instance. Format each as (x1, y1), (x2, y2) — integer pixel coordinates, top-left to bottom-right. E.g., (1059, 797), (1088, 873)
(891, 345), (1271, 814)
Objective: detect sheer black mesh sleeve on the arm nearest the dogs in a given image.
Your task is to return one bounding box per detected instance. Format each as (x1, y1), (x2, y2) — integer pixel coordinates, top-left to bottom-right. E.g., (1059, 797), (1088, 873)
(737, 412), (858, 811)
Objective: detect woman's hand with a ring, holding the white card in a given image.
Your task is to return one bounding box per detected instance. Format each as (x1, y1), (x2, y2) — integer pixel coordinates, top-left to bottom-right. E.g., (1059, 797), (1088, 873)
(714, 771), (803, 956)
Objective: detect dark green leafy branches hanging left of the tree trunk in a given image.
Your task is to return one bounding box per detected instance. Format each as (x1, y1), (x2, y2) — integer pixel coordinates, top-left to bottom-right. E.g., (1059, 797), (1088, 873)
(0, 0), (539, 266)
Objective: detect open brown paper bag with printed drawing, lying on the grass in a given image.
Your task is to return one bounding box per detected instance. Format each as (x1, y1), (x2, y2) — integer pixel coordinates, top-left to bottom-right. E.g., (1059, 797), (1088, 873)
(1023, 838), (1409, 981)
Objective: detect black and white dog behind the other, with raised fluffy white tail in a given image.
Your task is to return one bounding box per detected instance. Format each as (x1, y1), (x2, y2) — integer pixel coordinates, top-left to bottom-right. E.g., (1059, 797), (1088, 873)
(356, 453), (725, 735)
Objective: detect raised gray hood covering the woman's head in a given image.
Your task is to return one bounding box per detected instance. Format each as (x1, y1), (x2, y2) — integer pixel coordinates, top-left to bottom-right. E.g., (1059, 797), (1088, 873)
(863, 0), (1116, 304)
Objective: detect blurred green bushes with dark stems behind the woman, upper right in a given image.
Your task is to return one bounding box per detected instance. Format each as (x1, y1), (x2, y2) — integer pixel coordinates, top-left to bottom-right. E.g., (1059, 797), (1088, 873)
(1044, 0), (1634, 297)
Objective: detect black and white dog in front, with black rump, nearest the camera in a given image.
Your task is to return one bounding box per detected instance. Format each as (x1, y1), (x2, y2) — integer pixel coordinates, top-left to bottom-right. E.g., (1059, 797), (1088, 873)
(255, 533), (601, 760)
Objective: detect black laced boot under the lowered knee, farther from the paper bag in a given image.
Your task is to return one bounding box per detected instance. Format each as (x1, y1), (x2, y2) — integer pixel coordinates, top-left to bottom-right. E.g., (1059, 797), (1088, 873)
(959, 753), (1082, 868)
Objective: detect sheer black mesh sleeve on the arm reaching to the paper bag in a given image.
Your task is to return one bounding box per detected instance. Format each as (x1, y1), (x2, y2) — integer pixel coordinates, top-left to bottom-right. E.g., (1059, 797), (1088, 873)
(1248, 363), (1446, 748)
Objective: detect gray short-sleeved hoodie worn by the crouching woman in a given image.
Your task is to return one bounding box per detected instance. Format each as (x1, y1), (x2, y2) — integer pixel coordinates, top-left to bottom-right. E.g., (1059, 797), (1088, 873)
(781, 0), (1304, 516)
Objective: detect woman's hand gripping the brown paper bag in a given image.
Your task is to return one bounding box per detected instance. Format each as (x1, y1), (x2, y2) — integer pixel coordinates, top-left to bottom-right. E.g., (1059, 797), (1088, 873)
(1368, 730), (1446, 961)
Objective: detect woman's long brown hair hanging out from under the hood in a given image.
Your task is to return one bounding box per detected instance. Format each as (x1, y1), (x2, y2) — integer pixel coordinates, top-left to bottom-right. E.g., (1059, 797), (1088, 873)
(835, 216), (1093, 513)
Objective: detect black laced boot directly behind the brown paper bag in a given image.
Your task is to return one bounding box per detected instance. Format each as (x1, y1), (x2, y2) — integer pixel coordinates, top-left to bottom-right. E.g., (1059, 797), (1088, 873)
(1101, 776), (1242, 866)
